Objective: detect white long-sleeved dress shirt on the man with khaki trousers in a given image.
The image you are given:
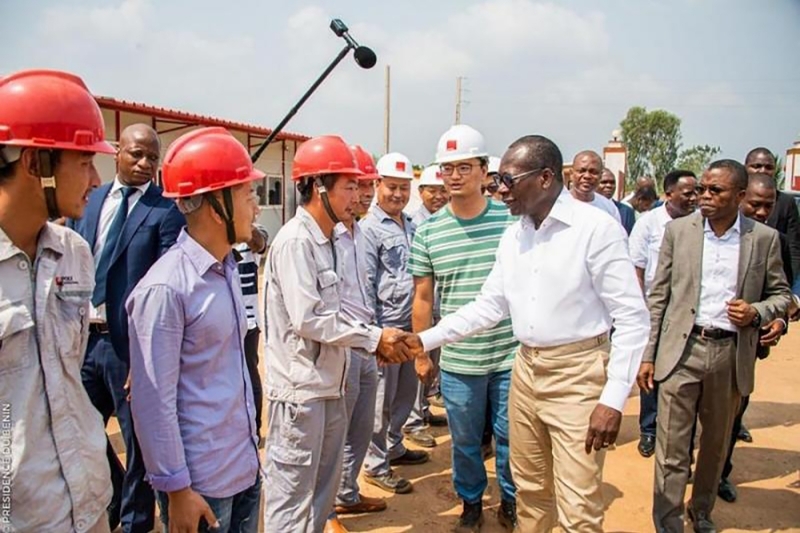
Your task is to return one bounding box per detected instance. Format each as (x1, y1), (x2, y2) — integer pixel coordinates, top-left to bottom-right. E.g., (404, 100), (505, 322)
(420, 190), (650, 411)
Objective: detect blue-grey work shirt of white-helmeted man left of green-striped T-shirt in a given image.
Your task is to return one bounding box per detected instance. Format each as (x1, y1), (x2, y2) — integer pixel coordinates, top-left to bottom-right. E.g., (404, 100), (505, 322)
(360, 205), (416, 330)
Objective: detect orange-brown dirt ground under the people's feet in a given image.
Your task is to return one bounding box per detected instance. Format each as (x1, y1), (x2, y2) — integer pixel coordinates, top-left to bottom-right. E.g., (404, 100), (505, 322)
(109, 327), (800, 533)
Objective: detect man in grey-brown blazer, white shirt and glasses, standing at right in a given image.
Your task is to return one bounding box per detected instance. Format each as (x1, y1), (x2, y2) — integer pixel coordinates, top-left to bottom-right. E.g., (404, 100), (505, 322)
(637, 159), (791, 533)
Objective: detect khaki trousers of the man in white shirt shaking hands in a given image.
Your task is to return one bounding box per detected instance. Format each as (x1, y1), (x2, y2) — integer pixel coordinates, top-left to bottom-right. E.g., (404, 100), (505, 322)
(508, 335), (609, 533)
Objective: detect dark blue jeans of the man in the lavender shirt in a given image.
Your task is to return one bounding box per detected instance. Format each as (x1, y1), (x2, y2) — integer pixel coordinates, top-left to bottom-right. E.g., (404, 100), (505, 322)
(156, 474), (261, 533)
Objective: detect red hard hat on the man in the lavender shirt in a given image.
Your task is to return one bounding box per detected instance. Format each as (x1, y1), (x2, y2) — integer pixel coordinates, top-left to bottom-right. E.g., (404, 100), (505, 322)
(161, 128), (265, 198)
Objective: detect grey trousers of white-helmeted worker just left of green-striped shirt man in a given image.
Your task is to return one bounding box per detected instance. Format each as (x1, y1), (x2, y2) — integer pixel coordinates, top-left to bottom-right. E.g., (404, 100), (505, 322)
(364, 361), (418, 476)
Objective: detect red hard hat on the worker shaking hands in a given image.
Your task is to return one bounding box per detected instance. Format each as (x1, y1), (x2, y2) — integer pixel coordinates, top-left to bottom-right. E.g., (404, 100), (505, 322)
(292, 135), (364, 181)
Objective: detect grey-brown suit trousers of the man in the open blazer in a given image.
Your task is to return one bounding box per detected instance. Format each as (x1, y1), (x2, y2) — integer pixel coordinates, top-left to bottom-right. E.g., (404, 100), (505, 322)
(653, 334), (741, 533)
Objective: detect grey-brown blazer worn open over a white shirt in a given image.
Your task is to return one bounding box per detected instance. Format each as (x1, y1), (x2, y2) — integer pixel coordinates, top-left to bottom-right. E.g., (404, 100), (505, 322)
(642, 212), (791, 396)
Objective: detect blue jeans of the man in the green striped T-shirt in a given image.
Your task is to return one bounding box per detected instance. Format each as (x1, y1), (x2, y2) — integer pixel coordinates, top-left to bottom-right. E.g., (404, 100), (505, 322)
(440, 370), (516, 503)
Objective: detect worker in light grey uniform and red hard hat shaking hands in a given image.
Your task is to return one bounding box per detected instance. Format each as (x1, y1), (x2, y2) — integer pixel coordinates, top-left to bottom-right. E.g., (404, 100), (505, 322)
(264, 136), (410, 533)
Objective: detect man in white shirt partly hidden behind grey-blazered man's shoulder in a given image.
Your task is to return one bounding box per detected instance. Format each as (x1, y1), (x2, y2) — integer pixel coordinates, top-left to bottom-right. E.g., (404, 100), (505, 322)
(629, 170), (697, 457)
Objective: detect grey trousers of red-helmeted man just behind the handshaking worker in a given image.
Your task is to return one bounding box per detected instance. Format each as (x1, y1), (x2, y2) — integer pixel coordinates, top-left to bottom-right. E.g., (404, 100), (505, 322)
(336, 350), (378, 505)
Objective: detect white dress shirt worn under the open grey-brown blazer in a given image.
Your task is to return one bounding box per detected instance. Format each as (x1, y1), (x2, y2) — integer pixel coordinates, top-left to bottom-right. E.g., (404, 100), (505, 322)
(695, 215), (741, 331)
